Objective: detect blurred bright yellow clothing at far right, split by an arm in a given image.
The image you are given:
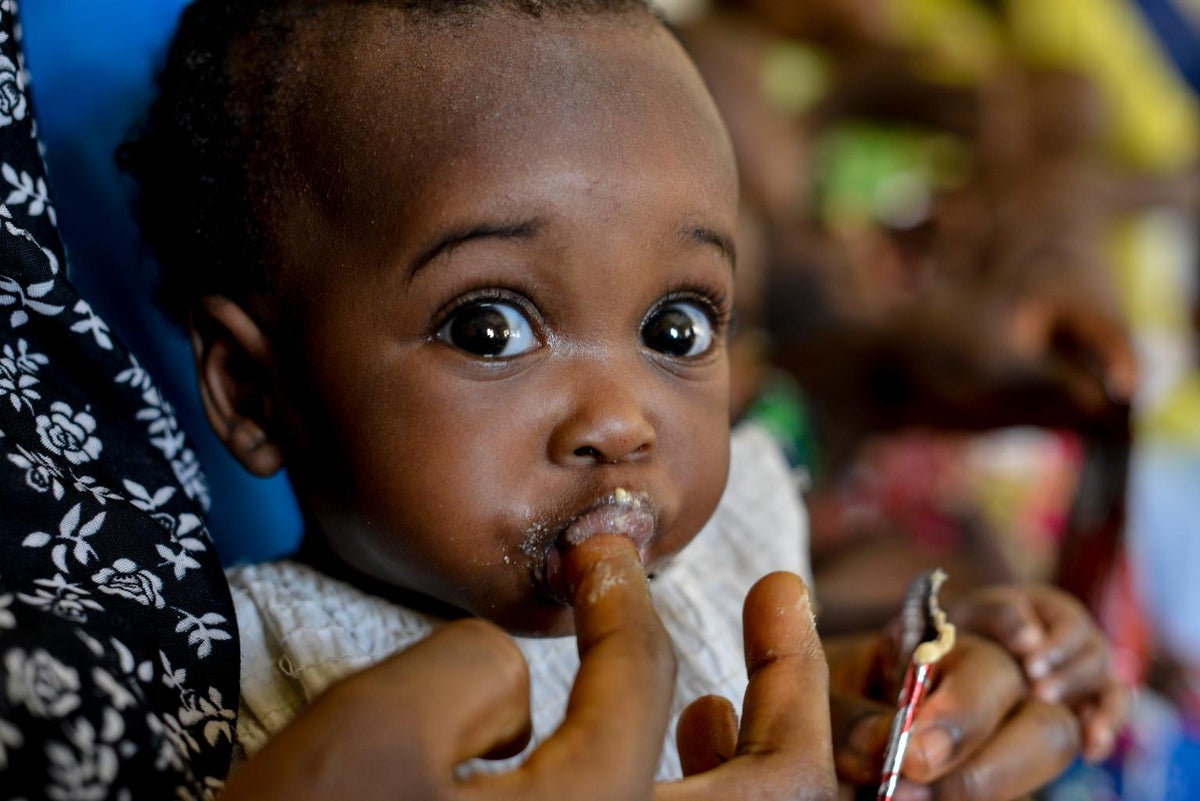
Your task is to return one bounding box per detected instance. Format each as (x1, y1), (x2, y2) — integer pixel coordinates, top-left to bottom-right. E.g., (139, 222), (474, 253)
(1006, 0), (1200, 438)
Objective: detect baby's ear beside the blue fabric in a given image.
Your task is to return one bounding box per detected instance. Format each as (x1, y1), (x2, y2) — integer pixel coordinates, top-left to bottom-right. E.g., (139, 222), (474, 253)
(190, 295), (283, 477)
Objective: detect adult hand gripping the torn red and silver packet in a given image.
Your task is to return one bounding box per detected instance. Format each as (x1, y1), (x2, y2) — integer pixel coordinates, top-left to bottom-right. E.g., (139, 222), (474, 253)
(827, 634), (1080, 801)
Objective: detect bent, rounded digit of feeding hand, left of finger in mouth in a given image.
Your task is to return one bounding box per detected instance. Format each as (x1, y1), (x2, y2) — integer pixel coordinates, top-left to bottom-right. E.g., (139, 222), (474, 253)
(221, 619), (529, 801)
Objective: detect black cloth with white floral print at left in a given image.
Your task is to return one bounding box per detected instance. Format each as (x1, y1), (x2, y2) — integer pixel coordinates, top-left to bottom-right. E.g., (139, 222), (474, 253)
(0, 0), (239, 801)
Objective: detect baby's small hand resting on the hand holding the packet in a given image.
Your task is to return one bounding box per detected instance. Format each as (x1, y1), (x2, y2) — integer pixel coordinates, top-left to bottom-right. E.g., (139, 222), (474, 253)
(952, 584), (1129, 761)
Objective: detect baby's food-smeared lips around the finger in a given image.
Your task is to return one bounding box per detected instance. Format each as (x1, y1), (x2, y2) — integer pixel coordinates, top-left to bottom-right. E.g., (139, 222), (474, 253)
(544, 487), (658, 603)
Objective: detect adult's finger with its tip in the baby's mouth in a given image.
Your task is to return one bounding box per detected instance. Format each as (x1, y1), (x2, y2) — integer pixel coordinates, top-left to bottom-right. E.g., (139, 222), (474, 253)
(488, 535), (676, 799)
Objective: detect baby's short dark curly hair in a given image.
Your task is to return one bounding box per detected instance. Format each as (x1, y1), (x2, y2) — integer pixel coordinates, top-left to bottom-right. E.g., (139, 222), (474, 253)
(118, 0), (654, 321)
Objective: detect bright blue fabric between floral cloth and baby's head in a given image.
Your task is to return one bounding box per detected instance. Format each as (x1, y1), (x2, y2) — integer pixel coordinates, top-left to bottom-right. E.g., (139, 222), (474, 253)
(22, 0), (301, 565)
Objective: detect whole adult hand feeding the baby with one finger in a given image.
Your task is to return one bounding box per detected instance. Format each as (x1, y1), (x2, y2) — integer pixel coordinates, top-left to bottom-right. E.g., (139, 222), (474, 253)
(222, 537), (836, 801)
